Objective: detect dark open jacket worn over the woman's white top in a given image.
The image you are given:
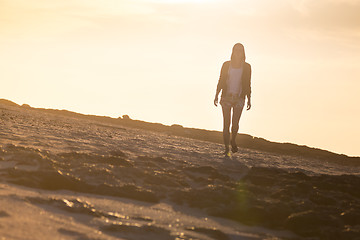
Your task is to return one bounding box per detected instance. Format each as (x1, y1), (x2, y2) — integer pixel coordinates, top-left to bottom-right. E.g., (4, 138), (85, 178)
(216, 61), (251, 99)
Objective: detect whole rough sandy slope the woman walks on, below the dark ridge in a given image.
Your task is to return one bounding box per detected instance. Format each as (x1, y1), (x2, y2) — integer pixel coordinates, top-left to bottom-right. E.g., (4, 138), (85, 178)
(0, 102), (360, 239)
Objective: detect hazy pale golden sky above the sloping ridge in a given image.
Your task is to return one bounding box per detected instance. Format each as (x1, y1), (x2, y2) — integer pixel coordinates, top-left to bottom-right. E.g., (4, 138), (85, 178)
(0, 0), (360, 156)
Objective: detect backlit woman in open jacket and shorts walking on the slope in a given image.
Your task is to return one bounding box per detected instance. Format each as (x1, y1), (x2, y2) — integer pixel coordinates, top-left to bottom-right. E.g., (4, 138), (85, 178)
(214, 43), (251, 156)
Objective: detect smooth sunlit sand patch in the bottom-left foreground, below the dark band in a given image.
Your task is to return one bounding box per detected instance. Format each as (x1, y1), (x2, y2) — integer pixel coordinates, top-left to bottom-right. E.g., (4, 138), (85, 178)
(0, 184), (294, 240)
